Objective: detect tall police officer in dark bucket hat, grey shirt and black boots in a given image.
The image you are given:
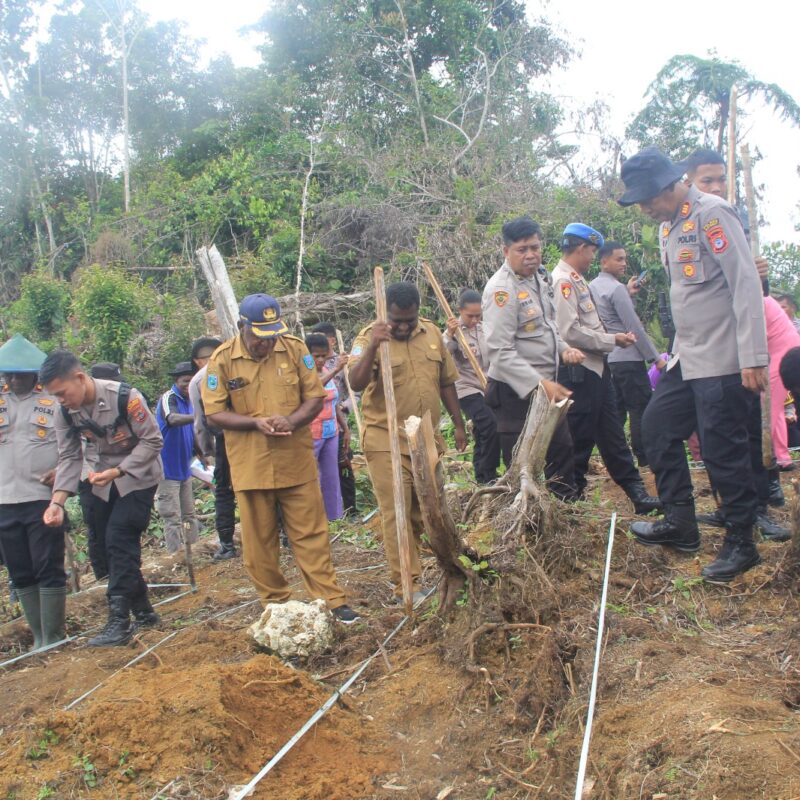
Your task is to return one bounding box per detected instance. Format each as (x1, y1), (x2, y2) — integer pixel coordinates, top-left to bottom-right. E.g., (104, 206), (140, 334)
(619, 147), (769, 583)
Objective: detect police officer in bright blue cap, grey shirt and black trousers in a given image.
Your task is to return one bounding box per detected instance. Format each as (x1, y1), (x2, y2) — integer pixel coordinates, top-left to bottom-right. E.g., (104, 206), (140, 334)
(553, 222), (661, 514)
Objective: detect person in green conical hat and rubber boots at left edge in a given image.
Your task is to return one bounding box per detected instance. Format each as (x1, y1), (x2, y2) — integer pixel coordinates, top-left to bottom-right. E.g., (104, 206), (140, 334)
(0, 334), (67, 650)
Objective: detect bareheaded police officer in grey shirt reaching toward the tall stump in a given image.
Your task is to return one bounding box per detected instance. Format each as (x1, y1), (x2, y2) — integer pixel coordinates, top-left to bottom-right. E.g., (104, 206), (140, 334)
(482, 217), (584, 500)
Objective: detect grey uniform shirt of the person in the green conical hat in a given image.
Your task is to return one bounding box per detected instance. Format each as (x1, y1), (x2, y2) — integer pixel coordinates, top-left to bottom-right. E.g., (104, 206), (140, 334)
(0, 386), (61, 505)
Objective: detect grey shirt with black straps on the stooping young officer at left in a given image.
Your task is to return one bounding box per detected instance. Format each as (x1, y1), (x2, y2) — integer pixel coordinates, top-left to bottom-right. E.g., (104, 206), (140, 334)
(53, 378), (164, 500)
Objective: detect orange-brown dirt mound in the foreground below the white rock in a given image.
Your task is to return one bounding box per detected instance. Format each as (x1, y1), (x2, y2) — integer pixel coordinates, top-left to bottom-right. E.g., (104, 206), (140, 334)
(0, 631), (391, 800)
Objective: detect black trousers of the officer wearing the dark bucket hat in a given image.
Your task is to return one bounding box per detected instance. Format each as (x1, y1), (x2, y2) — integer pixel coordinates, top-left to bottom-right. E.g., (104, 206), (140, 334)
(642, 364), (761, 526)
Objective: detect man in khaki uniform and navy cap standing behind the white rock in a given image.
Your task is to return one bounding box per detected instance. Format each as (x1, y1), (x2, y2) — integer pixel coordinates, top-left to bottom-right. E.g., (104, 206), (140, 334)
(202, 294), (358, 624)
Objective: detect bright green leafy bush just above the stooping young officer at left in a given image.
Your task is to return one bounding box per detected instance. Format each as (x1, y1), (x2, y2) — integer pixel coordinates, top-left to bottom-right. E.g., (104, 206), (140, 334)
(73, 266), (156, 364)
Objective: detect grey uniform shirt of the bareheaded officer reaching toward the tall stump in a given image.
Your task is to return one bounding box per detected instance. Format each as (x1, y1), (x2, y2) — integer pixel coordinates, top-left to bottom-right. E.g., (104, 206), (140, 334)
(482, 263), (568, 397)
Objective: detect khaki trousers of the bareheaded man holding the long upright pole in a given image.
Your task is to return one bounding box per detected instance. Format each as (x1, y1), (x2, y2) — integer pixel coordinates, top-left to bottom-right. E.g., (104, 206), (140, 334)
(364, 450), (428, 596)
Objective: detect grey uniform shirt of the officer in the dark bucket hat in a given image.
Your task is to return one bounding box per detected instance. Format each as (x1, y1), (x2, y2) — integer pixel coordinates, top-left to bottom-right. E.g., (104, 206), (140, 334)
(660, 186), (769, 380)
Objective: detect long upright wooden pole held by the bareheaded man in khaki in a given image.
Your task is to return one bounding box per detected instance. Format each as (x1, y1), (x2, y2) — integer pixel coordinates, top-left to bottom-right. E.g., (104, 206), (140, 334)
(374, 267), (414, 616)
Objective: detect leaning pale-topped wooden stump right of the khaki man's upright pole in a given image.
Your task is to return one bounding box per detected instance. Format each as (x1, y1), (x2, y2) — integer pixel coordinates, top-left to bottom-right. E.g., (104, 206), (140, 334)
(405, 411), (468, 611)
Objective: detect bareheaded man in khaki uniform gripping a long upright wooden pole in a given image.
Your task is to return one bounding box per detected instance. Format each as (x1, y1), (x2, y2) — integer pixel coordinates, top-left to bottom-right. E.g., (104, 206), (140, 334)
(350, 283), (467, 602)
